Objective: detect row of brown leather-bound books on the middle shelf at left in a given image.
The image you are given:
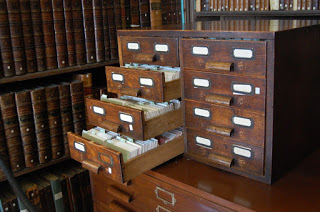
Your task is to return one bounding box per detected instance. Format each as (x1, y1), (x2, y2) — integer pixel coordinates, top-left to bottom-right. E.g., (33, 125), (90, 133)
(0, 81), (86, 172)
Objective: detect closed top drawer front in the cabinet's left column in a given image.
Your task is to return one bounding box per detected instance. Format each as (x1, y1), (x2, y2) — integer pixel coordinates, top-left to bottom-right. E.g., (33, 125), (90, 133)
(120, 36), (179, 67)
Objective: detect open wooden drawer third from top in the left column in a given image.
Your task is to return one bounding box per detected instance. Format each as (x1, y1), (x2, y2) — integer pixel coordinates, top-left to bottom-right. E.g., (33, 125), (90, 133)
(85, 98), (183, 141)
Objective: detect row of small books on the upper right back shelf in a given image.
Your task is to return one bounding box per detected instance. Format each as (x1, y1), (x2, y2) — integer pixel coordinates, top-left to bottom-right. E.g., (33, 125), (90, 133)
(195, 0), (319, 12)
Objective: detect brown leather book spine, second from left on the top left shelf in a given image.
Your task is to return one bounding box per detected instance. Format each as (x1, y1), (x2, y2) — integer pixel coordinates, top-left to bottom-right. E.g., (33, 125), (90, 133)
(7, 0), (27, 75)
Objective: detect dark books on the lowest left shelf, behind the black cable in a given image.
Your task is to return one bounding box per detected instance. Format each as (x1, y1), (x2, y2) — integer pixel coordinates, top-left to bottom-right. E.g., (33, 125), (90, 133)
(0, 161), (93, 212)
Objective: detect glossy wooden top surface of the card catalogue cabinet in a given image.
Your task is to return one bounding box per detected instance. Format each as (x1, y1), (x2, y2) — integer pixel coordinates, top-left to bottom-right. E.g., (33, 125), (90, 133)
(118, 20), (320, 39)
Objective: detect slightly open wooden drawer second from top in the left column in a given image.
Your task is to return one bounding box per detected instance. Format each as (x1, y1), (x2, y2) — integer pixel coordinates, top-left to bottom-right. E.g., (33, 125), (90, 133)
(106, 66), (181, 102)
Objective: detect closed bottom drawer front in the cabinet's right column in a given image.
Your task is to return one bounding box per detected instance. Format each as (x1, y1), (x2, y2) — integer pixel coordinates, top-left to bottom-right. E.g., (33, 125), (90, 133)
(187, 129), (264, 175)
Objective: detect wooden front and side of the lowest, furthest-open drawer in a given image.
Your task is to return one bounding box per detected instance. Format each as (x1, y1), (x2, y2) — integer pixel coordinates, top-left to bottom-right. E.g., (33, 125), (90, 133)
(68, 132), (184, 183)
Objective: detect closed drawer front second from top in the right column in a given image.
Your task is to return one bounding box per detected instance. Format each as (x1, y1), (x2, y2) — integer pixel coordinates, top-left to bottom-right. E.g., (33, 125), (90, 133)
(183, 70), (266, 113)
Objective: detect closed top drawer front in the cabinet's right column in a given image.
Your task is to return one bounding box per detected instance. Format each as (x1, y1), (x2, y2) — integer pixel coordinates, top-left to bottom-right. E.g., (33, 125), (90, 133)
(181, 39), (266, 78)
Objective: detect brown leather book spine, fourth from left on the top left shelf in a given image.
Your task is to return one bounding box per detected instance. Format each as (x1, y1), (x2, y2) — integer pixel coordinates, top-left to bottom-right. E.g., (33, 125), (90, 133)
(40, 0), (58, 69)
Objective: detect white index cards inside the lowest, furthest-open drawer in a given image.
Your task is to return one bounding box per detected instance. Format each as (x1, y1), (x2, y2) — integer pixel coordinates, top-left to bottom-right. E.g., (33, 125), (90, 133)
(82, 127), (183, 162)
